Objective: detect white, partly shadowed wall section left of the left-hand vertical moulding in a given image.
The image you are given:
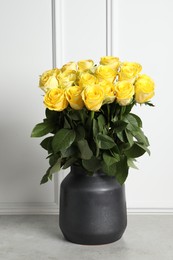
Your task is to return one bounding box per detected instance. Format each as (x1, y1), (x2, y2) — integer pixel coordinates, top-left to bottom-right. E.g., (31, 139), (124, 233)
(0, 0), (58, 213)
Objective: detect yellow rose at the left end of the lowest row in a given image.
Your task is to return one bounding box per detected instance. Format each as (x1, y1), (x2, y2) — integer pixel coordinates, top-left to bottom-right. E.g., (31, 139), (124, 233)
(44, 88), (68, 111)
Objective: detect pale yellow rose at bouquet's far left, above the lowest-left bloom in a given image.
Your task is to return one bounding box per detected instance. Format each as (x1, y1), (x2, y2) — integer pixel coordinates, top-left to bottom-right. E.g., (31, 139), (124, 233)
(39, 69), (60, 92)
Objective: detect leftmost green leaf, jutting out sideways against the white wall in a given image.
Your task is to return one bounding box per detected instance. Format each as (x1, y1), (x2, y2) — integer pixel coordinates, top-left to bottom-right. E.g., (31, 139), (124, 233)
(31, 122), (54, 137)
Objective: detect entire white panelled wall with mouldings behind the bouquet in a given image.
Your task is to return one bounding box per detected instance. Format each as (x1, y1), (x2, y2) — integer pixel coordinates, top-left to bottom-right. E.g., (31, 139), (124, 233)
(0, 0), (173, 214)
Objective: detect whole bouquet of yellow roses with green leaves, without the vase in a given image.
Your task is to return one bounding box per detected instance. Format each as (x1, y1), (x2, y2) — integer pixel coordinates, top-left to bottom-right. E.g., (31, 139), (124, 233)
(31, 56), (155, 184)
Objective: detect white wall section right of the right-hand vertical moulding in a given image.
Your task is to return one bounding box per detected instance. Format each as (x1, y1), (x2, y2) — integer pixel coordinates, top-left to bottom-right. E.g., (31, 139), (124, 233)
(113, 0), (173, 212)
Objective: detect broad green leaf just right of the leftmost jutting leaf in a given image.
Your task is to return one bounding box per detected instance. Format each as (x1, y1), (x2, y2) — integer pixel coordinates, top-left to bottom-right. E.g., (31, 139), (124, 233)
(52, 129), (76, 153)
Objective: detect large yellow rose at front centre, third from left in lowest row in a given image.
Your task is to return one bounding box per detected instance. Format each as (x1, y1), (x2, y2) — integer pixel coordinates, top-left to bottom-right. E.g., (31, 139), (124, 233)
(82, 85), (104, 111)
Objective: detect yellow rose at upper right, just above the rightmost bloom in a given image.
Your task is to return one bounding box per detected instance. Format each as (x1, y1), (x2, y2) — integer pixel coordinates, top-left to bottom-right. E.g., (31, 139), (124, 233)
(119, 62), (142, 80)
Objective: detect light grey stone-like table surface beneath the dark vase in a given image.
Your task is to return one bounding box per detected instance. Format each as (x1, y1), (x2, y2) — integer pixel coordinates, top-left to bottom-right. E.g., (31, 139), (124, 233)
(0, 215), (173, 260)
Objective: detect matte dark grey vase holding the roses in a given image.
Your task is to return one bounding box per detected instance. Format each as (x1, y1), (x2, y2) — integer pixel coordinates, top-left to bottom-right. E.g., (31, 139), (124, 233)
(59, 166), (127, 245)
